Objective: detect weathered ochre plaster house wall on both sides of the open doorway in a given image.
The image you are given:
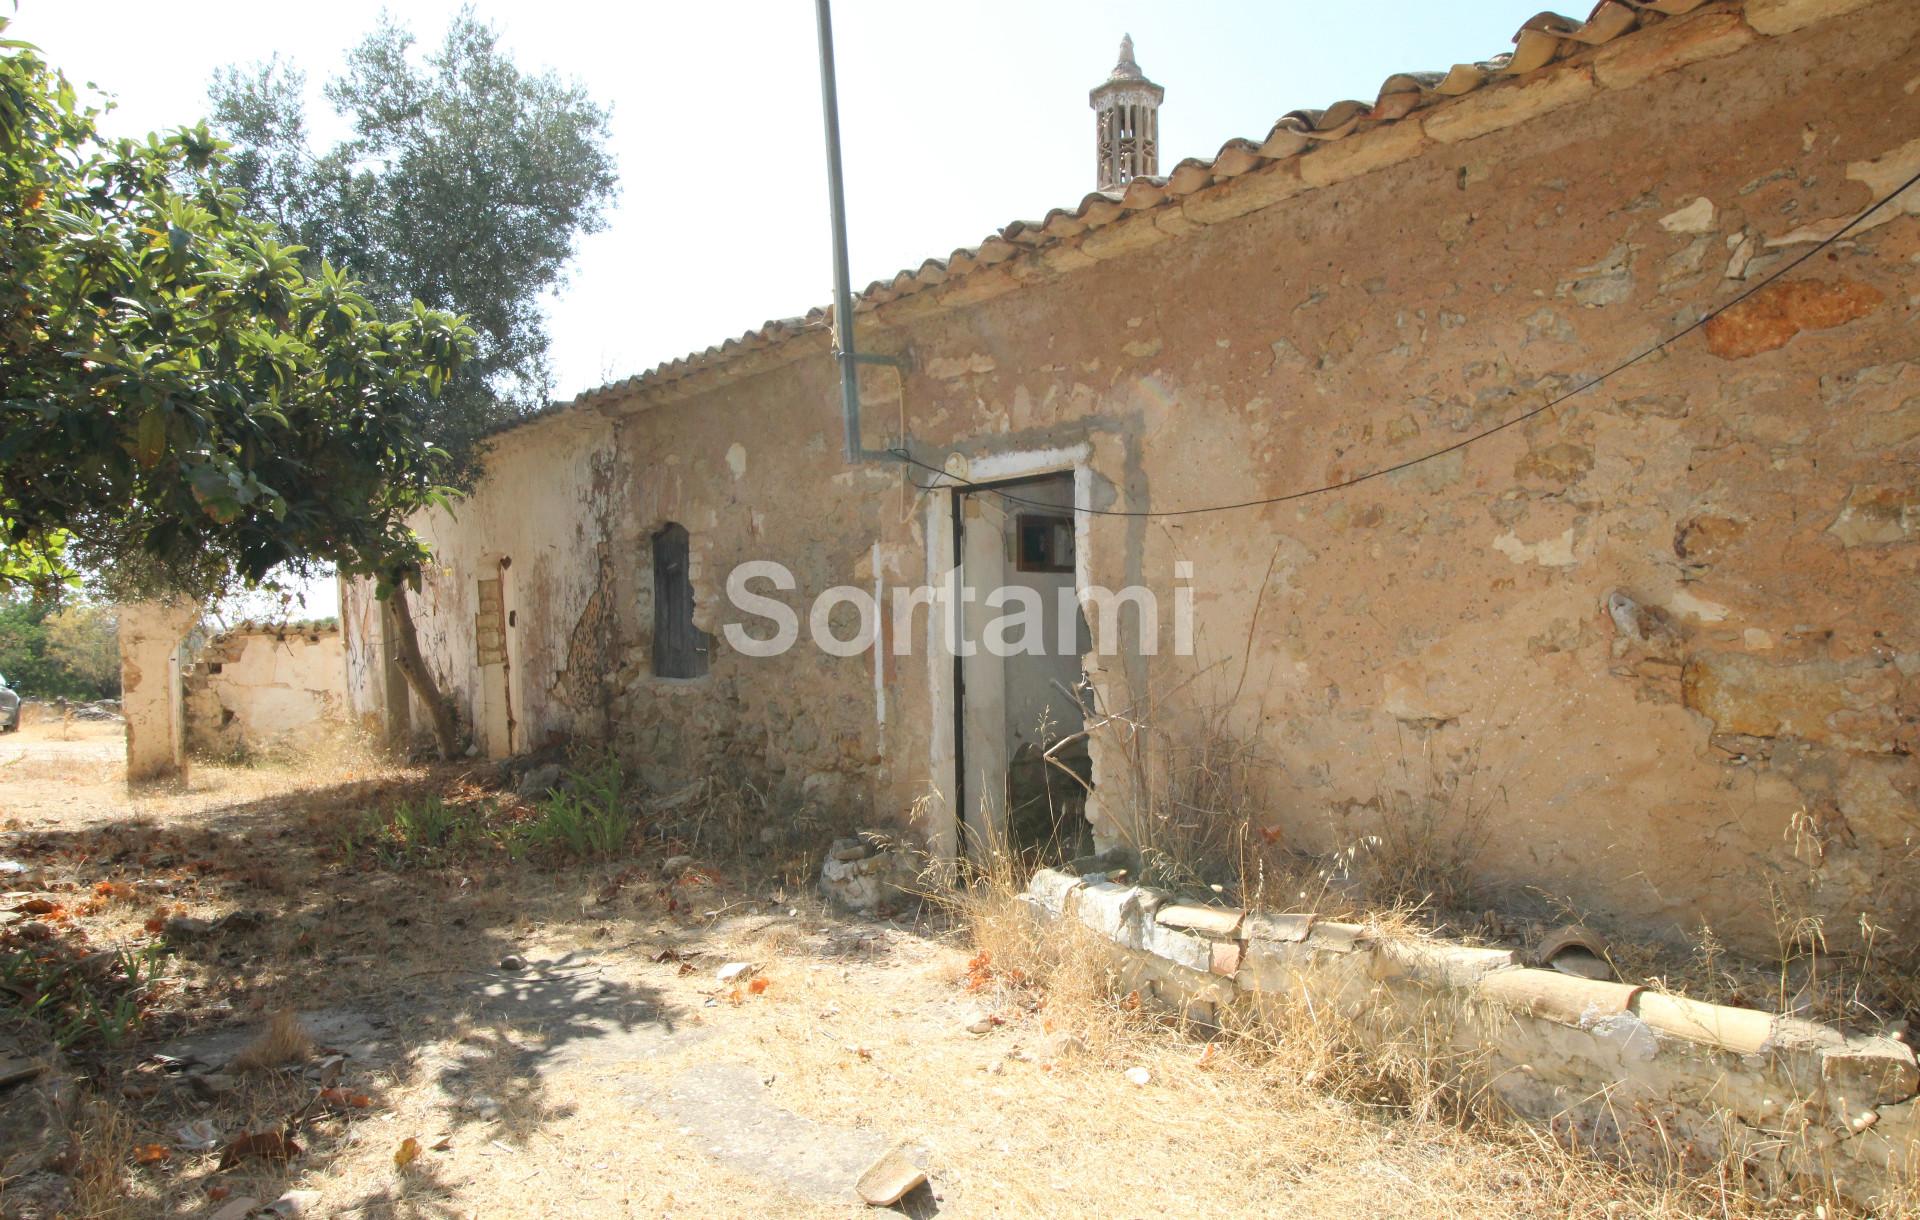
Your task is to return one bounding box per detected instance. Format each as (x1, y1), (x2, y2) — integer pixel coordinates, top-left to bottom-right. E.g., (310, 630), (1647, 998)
(591, 2), (1920, 949)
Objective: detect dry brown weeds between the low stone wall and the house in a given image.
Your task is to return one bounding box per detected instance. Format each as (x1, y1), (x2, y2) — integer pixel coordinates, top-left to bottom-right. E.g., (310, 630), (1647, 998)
(1091, 699), (1920, 1034)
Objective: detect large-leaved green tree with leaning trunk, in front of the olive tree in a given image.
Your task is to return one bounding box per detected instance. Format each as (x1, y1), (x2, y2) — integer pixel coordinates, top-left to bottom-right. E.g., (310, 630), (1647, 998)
(0, 25), (472, 753)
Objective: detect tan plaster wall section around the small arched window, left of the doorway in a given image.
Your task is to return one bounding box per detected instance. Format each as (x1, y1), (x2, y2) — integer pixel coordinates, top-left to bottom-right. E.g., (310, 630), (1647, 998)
(599, 336), (906, 813)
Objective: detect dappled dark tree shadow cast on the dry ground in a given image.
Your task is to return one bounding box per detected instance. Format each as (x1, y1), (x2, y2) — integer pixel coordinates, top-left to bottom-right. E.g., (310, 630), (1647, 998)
(0, 770), (710, 1216)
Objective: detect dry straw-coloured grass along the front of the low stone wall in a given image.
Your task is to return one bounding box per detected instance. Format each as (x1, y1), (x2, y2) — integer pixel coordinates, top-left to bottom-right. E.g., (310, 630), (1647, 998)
(954, 860), (1916, 1220)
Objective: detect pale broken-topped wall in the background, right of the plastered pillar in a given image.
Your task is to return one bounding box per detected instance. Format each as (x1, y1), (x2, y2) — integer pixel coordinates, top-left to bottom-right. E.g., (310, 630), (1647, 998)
(184, 626), (346, 757)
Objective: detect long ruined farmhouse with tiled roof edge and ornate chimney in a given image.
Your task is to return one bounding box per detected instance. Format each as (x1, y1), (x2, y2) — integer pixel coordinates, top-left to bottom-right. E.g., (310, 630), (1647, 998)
(344, 0), (1920, 947)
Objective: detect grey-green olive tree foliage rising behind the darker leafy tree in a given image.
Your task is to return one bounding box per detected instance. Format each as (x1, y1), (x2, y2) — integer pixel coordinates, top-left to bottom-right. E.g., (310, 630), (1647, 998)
(209, 10), (616, 484)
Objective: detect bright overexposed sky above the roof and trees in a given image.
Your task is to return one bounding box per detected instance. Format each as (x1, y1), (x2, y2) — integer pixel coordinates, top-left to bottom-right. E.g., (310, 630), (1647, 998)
(6, 0), (1536, 615)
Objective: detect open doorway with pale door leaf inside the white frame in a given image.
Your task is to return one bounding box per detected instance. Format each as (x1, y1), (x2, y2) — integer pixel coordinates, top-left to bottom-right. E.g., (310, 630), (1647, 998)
(954, 473), (1092, 865)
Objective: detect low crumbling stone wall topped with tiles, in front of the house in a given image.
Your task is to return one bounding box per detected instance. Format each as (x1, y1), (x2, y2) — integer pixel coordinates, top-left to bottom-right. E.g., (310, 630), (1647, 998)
(1025, 868), (1920, 1207)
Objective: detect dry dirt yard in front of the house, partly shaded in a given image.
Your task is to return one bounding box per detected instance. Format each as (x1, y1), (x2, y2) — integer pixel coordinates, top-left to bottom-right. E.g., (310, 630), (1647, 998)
(0, 724), (1858, 1218)
